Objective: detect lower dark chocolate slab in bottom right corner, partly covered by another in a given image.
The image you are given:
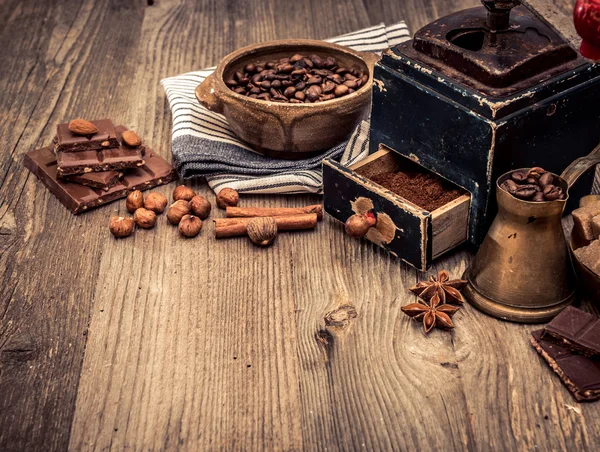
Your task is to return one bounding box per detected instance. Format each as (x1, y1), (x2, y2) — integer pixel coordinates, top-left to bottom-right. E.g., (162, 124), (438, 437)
(531, 330), (600, 402)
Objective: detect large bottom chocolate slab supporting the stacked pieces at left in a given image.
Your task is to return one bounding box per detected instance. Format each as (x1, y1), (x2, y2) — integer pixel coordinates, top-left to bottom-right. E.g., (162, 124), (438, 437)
(24, 147), (177, 214)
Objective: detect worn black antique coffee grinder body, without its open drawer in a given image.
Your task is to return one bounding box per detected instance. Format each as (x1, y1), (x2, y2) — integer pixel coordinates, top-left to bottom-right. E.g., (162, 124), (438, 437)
(369, 0), (600, 245)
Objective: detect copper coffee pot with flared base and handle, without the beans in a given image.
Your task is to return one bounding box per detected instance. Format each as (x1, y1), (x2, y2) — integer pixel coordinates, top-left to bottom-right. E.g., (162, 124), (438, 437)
(463, 146), (600, 323)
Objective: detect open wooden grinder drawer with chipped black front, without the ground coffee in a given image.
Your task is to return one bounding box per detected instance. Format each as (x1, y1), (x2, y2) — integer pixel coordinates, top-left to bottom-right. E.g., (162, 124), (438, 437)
(323, 145), (471, 271)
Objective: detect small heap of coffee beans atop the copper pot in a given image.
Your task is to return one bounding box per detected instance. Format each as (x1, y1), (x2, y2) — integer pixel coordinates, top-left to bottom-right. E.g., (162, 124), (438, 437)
(500, 166), (567, 202)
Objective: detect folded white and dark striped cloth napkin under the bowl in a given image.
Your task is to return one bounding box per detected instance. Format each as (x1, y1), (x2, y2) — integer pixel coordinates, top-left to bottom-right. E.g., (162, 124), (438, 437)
(161, 22), (410, 194)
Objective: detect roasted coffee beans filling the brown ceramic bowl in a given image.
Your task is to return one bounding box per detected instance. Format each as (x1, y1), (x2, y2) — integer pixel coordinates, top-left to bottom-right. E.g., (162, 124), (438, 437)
(225, 54), (369, 104)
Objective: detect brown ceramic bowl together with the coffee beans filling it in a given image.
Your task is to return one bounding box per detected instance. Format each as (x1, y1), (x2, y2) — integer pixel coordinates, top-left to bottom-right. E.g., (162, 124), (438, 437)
(196, 40), (379, 158)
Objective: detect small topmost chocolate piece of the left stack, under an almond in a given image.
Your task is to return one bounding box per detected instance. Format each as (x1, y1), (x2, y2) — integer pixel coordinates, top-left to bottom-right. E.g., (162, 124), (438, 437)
(56, 119), (120, 152)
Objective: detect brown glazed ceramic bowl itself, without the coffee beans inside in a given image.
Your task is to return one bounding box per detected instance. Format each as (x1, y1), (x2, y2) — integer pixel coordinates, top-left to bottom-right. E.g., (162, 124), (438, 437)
(196, 39), (379, 158)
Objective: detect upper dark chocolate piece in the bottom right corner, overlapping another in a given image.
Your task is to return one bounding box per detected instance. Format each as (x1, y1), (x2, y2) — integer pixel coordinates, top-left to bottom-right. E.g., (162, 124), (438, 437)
(544, 306), (600, 356)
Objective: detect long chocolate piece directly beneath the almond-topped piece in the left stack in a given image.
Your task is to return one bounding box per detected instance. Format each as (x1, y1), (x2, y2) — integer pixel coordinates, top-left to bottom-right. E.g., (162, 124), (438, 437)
(56, 146), (144, 179)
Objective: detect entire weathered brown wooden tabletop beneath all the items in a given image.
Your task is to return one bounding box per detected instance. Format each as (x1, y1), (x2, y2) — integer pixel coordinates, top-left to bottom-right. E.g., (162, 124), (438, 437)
(0, 0), (600, 451)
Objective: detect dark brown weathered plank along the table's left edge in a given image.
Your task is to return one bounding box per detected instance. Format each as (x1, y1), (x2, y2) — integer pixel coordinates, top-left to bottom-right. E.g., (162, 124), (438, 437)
(0, 1), (148, 450)
